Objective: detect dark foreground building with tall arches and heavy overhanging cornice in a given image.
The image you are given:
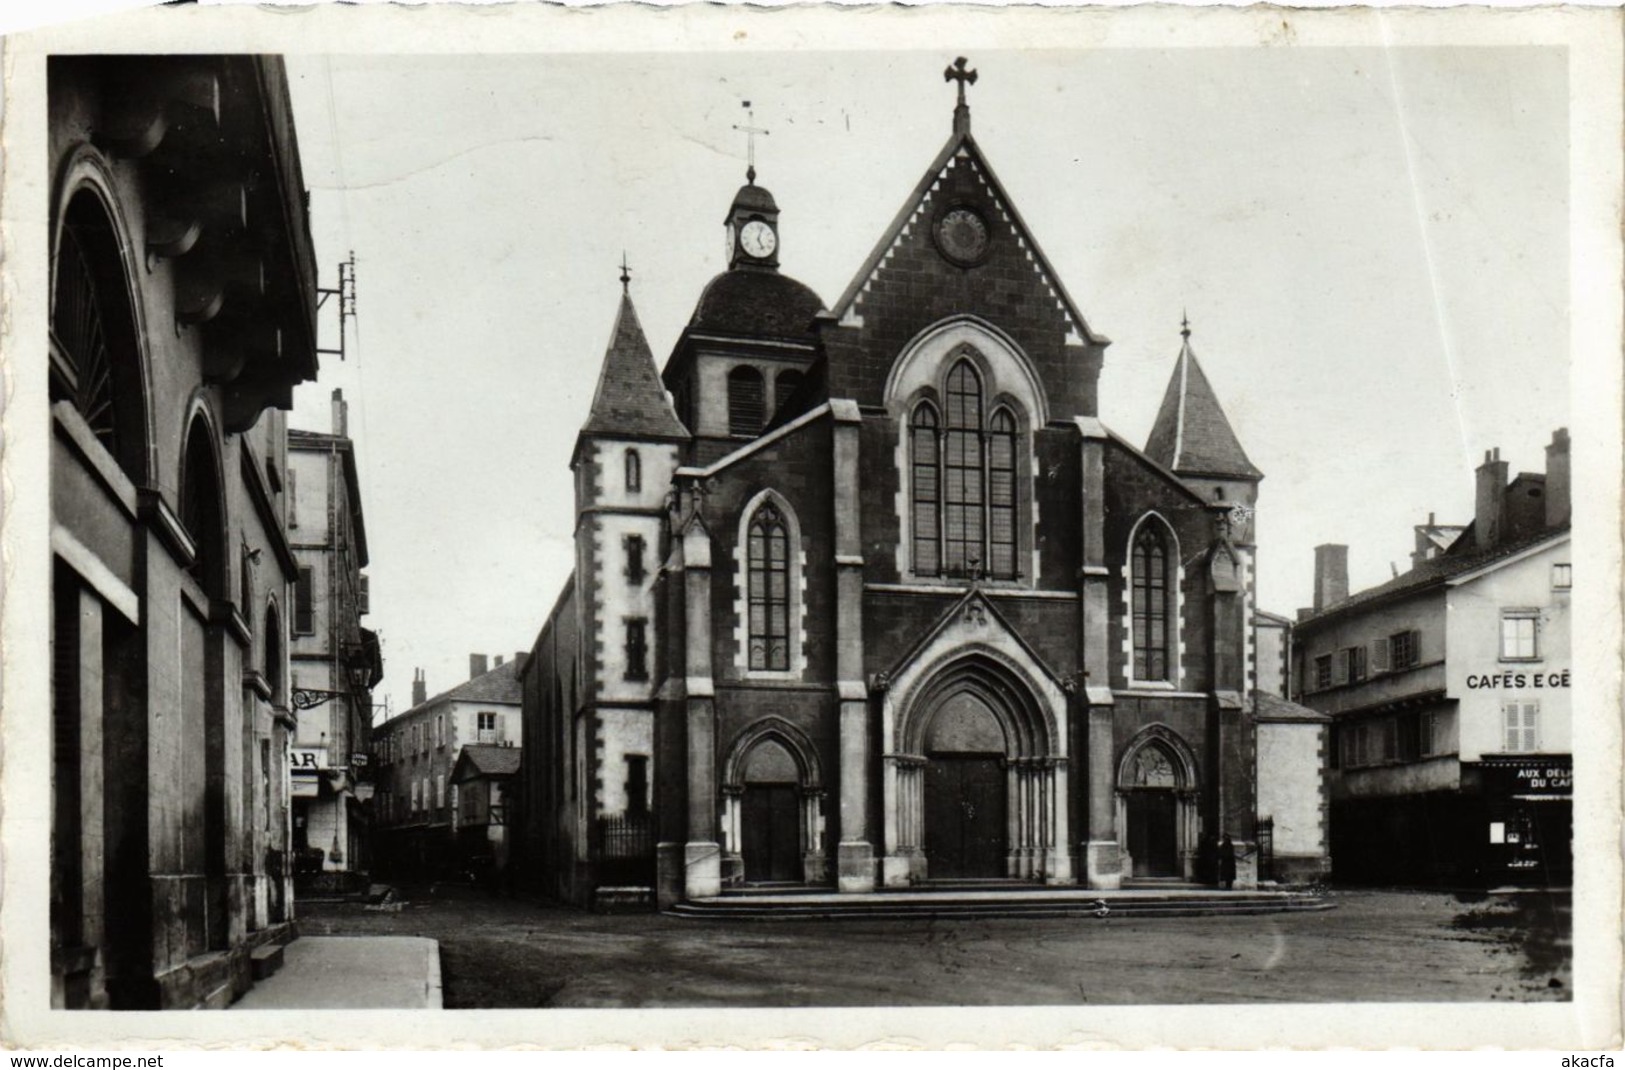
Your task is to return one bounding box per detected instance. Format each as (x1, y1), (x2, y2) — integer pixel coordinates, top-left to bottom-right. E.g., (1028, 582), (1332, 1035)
(46, 55), (317, 1008)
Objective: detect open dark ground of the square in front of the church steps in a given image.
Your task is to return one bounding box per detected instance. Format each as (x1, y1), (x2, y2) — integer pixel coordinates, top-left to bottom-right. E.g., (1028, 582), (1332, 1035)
(299, 885), (1571, 1008)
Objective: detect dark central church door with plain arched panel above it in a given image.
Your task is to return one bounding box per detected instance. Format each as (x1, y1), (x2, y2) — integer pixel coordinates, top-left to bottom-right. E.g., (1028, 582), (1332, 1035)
(923, 691), (1009, 880)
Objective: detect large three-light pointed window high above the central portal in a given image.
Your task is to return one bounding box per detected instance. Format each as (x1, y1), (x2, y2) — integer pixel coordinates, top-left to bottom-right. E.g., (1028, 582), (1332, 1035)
(908, 359), (1021, 579)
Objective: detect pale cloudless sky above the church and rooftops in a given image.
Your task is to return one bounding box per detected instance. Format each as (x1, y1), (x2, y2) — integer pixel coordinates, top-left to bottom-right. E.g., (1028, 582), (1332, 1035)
(273, 47), (1570, 712)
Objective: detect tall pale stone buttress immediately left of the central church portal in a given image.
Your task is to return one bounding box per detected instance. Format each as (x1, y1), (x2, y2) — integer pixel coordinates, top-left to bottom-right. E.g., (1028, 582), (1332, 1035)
(830, 398), (874, 893)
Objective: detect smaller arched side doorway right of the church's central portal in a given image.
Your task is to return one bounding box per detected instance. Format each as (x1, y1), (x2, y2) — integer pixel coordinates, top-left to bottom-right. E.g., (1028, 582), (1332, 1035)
(1116, 725), (1198, 880)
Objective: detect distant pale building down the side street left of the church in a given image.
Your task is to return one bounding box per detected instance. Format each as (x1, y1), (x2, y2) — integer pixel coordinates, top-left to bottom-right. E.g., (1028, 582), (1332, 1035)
(372, 654), (525, 880)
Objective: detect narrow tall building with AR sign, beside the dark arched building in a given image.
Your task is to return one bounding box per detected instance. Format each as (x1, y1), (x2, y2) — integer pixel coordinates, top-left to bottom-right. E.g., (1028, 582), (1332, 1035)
(288, 390), (384, 893)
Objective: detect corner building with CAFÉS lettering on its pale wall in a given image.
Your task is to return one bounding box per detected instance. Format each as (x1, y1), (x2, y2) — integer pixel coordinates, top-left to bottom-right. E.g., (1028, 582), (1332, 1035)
(1294, 429), (1573, 883)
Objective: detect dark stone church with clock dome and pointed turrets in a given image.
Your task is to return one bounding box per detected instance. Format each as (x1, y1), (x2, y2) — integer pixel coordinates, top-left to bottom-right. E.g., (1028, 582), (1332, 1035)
(515, 63), (1263, 906)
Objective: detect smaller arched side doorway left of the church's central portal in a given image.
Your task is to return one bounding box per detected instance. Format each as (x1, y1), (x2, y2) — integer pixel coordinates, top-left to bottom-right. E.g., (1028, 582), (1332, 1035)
(722, 717), (829, 885)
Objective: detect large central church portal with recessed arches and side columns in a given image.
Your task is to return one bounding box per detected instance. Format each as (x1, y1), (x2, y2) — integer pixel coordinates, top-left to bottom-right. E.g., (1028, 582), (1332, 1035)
(886, 652), (1071, 885)
